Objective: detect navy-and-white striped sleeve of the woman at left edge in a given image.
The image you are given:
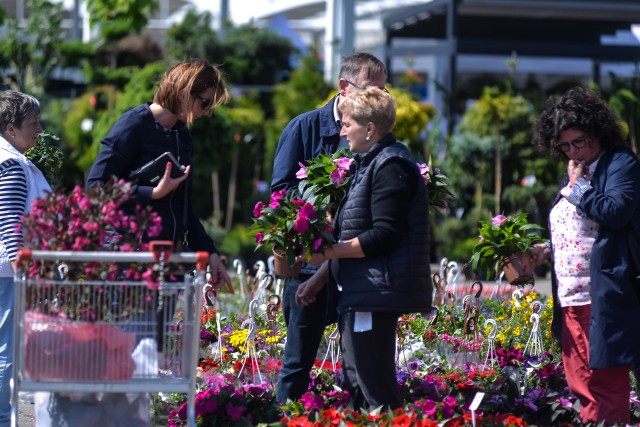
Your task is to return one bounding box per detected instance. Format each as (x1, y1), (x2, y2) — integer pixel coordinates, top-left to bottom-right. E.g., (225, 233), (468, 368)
(0, 159), (27, 260)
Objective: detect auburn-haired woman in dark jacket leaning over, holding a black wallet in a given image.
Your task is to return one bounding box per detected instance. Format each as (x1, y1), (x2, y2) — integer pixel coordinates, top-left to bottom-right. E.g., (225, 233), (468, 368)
(87, 59), (231, 286)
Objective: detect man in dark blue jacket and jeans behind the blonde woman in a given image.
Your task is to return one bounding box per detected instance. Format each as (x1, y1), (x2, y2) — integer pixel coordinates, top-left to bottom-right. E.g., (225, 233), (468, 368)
(271, 53), (387, 403)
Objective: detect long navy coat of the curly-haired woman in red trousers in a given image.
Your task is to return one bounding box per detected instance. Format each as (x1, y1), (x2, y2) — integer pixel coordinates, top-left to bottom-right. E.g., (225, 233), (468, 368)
(552, 148), (640, 369)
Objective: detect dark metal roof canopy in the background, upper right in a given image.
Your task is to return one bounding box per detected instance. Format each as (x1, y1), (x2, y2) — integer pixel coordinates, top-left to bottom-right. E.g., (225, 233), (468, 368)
(383, 0), (640, 130)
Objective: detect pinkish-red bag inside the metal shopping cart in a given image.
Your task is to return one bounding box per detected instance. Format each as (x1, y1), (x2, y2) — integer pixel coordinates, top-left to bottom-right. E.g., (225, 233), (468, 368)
(24, 310), (135, 381)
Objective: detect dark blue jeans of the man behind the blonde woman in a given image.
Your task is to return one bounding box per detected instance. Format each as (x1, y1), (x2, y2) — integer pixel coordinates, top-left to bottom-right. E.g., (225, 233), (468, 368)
(276, 275), (327, 403)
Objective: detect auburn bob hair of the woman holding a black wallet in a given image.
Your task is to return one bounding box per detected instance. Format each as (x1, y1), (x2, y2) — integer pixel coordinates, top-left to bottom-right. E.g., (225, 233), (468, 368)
(153, 59), (230, 123)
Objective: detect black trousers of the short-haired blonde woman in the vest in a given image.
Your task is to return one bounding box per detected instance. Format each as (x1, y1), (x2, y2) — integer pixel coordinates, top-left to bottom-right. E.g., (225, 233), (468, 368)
(340, 312), (402, 410)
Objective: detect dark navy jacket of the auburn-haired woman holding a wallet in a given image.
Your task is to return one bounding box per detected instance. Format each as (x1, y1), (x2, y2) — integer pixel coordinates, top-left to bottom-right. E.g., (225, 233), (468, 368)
(87, 104), (218, 253)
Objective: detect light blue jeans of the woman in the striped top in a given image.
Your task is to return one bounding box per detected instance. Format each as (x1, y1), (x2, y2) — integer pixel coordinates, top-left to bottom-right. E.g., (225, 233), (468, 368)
(0, 277), (15, 427)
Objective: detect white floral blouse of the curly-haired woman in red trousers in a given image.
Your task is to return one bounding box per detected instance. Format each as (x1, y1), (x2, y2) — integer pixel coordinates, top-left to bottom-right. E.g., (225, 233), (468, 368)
(549, 161), (600, 307)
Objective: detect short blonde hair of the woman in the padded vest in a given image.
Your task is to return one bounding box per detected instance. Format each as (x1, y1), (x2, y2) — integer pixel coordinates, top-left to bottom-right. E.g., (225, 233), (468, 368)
(338, 86), (398, 135)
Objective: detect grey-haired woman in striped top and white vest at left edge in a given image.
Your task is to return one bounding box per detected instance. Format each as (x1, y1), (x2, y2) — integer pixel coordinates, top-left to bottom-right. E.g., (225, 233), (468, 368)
(0, 90), (51, 427)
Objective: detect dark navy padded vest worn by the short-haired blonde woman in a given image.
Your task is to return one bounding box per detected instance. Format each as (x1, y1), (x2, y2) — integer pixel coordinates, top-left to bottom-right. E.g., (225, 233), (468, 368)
(331, 135), (432, 314)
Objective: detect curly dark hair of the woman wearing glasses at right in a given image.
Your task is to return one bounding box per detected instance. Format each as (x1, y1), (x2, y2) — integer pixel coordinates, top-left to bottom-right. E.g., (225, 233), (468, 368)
(532, 87), (624, 158)
